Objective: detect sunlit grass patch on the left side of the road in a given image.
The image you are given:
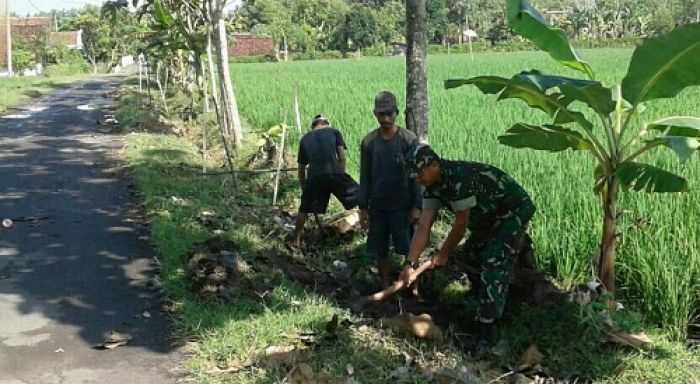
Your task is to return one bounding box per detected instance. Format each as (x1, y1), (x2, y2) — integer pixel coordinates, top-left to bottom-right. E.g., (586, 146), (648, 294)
(0, 75), (90, 113)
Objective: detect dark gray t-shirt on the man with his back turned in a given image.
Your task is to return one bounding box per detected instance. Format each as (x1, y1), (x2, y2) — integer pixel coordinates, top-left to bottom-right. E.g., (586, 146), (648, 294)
(297, 127), (347, 178)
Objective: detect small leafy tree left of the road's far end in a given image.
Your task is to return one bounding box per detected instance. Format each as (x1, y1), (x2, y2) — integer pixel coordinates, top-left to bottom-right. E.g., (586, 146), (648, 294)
(74, 5), (110, 73)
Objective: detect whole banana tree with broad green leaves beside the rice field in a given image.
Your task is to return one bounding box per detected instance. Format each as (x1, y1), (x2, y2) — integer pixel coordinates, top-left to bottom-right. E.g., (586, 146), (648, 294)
(445, 0), (700, 293)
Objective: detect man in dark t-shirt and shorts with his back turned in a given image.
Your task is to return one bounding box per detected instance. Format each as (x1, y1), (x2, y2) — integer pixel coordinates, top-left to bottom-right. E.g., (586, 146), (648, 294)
(292, 115), (359, 248)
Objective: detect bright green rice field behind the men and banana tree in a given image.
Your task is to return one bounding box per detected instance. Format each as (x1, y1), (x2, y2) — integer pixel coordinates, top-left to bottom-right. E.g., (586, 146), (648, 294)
(231, 50), (700, 339)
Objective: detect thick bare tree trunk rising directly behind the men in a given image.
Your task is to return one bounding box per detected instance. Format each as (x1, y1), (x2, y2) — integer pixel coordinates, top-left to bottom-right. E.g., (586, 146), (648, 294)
(406, 0), (428, 142)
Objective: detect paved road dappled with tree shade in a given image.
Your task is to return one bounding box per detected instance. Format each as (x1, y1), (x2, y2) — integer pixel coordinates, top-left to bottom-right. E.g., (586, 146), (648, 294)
(0, 78), (179, 384)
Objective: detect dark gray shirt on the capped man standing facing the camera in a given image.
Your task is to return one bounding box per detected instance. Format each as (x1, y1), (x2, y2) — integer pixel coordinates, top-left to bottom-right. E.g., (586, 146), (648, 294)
(360, 128), (421, 211)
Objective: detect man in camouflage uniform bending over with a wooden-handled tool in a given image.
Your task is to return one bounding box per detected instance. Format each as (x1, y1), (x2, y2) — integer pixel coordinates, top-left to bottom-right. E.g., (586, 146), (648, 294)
(401, 145), (535, 343)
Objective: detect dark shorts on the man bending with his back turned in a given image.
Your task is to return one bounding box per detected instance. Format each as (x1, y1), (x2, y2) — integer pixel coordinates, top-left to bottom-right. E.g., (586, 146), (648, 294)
(299, 173), (360, 213)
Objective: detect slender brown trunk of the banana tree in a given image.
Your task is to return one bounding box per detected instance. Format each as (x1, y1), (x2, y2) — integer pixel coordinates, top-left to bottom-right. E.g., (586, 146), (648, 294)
(598, 176), (620, 295)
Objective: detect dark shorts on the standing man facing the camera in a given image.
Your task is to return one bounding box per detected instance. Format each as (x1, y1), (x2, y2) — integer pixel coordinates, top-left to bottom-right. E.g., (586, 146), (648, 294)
(367, 209), (411, 256)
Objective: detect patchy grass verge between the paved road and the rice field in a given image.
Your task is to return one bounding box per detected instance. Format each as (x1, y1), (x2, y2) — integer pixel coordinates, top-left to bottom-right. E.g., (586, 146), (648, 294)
(120, 79), (700, 384)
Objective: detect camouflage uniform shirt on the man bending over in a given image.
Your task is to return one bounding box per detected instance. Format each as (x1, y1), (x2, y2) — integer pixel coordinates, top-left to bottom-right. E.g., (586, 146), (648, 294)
(423, 160), (531, 231)
